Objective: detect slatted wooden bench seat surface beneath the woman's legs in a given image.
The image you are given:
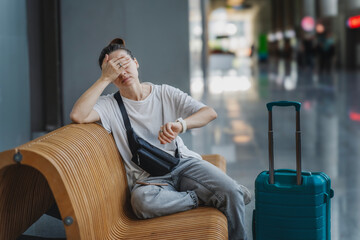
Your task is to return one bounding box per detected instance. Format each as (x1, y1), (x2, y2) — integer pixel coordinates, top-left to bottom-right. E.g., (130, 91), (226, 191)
(108, 207), (228, 240)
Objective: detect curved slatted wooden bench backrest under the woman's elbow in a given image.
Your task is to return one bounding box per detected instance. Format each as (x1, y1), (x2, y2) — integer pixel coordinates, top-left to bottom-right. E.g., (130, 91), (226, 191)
(0, 124), (131, 239)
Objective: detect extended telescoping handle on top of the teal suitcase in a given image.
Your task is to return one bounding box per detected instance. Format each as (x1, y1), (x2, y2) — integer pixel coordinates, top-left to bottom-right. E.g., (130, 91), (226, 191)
(266, 101), (301, 185)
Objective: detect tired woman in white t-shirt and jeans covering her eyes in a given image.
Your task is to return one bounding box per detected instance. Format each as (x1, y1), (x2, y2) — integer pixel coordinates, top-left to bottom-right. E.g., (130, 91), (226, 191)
(70, 38), (250, 240)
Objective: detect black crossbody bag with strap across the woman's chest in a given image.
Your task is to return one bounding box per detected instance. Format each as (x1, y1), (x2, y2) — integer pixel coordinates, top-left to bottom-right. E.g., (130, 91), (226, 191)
(114, 92), (180, 176)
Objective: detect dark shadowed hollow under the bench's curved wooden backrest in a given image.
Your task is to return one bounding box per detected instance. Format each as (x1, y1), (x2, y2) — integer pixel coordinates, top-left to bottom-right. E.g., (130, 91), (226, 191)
(0, 164), (54, 239)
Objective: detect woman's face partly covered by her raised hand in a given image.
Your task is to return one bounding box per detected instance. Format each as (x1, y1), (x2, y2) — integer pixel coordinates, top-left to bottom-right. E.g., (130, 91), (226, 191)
(109, 49), (140, 87)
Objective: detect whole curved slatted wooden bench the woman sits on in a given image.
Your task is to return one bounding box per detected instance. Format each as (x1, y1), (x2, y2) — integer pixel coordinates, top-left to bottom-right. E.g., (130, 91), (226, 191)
(0, 124), (228, 240)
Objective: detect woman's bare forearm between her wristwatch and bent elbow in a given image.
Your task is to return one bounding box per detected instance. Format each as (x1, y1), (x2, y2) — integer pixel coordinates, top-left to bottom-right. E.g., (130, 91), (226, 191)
(184, 106), (217, 129)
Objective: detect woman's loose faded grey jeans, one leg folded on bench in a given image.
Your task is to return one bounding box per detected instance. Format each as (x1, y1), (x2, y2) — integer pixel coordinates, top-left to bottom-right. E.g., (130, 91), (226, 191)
(131, 158), (247, 240)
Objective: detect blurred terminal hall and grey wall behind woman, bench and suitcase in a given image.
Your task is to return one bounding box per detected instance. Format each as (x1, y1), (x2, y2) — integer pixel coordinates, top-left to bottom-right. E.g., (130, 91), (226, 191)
(0, 0), (360, 240)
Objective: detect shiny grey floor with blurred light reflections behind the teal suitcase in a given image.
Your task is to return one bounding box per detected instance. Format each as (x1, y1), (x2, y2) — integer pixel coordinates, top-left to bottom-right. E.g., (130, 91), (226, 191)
(192, 59), (360, 240)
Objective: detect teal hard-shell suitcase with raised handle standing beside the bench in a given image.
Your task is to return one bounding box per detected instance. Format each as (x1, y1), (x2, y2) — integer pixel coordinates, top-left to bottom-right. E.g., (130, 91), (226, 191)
(253, 101), (334, 240)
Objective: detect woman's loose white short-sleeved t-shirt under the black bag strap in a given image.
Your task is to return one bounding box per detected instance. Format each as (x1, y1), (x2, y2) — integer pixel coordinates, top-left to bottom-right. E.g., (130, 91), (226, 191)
(94, 83), (205, 189)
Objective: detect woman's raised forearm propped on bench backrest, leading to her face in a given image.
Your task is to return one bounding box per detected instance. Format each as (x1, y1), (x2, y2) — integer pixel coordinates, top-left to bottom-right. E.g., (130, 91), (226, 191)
(70, 78), (111, 123)
